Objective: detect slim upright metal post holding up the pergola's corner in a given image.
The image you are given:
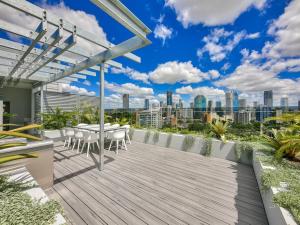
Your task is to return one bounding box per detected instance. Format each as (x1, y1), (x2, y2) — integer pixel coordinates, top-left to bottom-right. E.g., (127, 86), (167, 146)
(98, 63), (104, 171)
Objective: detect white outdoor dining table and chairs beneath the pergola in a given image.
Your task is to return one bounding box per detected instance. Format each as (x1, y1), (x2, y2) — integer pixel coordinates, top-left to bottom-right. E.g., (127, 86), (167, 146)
(63, 123), (131, 157)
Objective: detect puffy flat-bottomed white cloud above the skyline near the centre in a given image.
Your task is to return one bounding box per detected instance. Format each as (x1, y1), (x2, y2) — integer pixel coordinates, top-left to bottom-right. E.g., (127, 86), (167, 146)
(149, 61), (209, 84)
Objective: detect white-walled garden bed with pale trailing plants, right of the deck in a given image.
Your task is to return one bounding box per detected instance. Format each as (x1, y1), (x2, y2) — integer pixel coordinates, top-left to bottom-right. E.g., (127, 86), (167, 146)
(253, 151), (300, 225)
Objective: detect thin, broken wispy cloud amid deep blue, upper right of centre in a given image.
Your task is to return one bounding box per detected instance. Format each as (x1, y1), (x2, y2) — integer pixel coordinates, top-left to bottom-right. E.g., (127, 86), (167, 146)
(197, 28), (259, 62)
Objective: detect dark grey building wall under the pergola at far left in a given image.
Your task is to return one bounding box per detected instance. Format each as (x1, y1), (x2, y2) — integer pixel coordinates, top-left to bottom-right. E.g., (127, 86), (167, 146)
(0, 87), (31, 125)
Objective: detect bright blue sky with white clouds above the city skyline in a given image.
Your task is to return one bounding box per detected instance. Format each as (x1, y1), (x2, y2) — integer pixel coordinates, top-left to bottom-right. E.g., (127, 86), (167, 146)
(12, 0), (300, 107)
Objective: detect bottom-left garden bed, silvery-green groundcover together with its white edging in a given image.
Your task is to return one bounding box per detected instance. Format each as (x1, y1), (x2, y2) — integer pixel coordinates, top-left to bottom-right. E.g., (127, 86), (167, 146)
(0, 167), (66, 225)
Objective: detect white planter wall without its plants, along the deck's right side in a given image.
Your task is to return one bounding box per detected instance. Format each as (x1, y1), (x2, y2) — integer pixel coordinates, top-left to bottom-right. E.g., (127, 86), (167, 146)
(253, 151), (297, 225)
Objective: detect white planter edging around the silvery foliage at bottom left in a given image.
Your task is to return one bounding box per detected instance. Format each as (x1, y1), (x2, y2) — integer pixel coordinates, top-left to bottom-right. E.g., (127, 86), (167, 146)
(4, 167), (66, 225)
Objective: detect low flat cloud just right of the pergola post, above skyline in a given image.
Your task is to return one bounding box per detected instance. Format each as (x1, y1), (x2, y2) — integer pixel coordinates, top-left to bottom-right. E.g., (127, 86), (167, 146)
(105, 81), (154, 97)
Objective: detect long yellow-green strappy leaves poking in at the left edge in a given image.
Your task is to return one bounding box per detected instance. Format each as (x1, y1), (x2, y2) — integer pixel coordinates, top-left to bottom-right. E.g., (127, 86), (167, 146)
(0, 124), (41, 164)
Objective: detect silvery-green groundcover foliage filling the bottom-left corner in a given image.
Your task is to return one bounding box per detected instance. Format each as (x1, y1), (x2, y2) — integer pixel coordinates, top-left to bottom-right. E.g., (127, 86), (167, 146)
(0, 176), (62, 225)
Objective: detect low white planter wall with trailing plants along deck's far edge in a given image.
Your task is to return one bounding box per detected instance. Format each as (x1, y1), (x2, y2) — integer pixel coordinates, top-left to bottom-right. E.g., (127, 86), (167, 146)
(131, 129), (252, 165)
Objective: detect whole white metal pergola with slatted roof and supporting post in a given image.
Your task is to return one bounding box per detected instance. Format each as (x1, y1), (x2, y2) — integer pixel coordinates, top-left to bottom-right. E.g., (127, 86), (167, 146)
(0, 0), (151, 170)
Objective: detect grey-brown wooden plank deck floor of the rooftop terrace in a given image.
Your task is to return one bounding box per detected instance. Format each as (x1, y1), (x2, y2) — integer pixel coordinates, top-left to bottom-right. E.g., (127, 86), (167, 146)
(48, 143), (268, 225)
